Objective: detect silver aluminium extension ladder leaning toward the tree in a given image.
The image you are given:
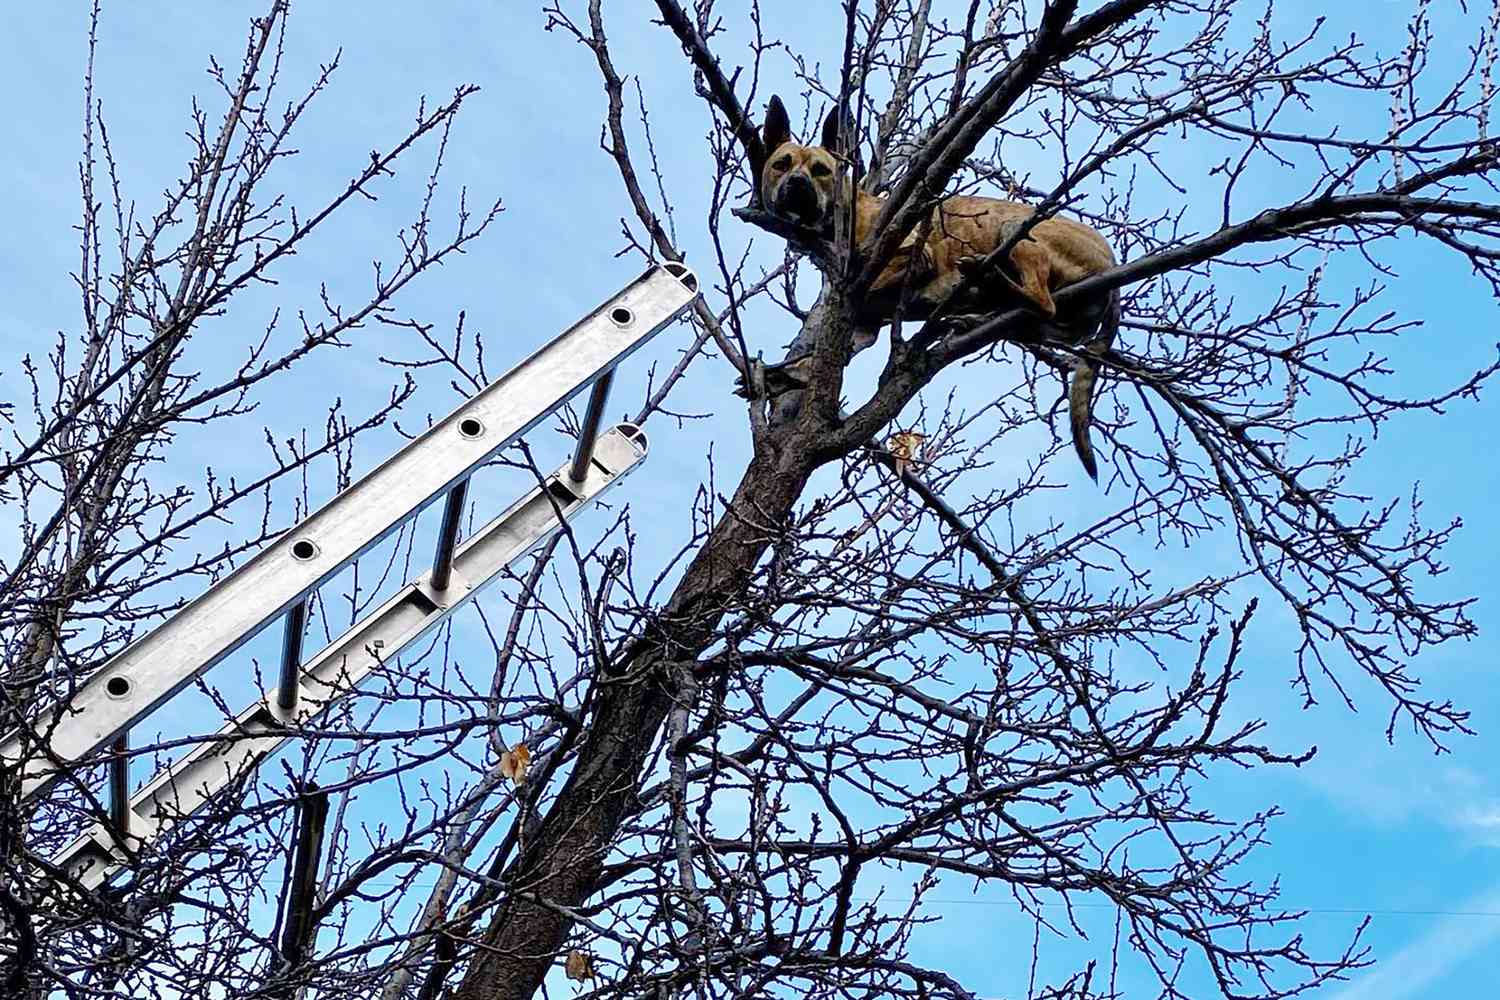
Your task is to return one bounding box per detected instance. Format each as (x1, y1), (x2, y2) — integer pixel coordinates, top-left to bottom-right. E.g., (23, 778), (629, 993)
(0, 264), (698, 889)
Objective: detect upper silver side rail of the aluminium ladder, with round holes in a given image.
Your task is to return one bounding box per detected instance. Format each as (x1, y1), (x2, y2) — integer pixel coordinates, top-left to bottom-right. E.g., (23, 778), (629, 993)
(0, 264), (698, 798)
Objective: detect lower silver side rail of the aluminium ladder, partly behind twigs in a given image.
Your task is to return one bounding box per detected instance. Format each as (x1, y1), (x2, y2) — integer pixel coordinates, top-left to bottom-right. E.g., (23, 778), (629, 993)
(53, 424), (647, 889)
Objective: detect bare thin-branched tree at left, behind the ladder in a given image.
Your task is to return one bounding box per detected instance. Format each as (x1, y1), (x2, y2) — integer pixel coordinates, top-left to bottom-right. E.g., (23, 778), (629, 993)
(0, 0), (500, 996)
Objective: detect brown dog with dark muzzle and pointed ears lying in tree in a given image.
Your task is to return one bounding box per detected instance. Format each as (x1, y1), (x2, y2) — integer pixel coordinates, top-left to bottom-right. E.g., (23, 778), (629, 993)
(761, 97), (1119, 478)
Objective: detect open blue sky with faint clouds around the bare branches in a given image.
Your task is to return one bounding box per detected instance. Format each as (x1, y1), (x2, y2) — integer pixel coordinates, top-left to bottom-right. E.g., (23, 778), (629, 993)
(0, 0), (1500, 1000)
